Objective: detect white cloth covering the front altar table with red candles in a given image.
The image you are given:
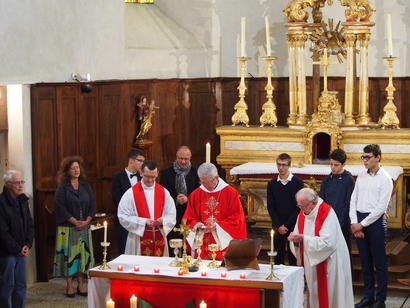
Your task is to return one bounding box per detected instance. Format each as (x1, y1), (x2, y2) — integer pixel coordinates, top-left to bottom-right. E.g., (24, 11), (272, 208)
(88, 255), (305, 308)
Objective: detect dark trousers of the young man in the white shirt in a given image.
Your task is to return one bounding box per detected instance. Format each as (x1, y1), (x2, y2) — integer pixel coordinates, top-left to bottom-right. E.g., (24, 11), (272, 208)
(356, 212), (387, 301)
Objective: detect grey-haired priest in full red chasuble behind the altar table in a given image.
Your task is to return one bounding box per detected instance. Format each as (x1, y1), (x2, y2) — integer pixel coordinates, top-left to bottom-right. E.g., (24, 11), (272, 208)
(183, 163), (246, 260)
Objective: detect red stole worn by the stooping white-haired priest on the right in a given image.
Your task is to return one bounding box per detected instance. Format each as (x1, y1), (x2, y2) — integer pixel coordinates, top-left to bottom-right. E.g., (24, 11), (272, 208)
(298, 202), (331, 308)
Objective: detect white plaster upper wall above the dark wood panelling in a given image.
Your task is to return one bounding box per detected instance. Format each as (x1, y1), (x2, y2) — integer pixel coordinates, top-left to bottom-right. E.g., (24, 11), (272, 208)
(0, 0), (410, 83)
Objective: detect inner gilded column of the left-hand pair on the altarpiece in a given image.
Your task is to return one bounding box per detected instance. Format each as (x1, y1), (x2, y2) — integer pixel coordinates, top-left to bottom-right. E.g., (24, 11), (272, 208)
(296, 32), (308, 125)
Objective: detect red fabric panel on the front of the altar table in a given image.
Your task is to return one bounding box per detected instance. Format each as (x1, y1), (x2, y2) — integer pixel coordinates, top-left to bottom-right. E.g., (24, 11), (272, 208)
(110, 279), (260, 308)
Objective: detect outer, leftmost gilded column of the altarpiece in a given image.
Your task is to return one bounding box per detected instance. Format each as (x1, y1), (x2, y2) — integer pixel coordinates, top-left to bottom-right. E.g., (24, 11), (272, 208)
(287, 33), (297, 125)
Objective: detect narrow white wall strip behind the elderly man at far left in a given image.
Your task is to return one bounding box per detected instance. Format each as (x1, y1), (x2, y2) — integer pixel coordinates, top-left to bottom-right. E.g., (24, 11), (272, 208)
(7, 85), (36, 283)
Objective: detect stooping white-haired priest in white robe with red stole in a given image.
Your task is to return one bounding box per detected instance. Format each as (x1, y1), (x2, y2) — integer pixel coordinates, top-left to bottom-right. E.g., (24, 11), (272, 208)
(288, 188), (354, 308)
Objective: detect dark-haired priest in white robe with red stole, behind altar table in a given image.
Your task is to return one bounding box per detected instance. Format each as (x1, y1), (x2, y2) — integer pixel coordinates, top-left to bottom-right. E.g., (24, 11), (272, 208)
(118, 161), (176, 257)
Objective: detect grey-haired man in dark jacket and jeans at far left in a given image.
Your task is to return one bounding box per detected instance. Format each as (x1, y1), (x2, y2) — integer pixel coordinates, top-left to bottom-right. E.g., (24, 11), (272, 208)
(0, 170), (34, 307)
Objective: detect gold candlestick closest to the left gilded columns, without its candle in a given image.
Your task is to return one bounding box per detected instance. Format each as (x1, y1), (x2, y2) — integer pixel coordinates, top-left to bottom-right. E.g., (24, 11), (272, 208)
(259, 57), (278, 127)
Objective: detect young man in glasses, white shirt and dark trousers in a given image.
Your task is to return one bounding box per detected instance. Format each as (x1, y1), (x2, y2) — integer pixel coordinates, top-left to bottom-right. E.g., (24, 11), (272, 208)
(350, 144), (393, 308)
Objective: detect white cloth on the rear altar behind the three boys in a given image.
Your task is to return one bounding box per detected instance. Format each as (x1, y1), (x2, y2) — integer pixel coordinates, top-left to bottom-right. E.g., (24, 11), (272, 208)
(230, 162), (403, 181)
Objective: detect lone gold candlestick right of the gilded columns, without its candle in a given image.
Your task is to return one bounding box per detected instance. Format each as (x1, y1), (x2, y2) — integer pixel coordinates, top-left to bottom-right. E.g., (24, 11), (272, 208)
(379, 57), (400, 129)
